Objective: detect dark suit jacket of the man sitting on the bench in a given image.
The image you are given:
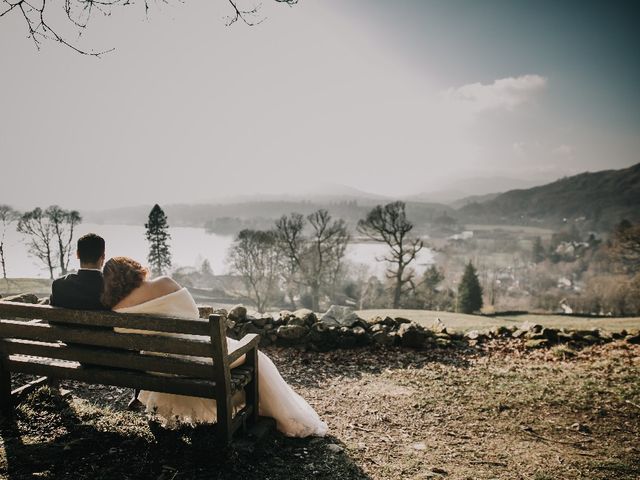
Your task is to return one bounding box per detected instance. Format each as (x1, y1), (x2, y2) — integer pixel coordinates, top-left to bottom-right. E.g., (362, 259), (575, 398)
(49, 269), (105, 310)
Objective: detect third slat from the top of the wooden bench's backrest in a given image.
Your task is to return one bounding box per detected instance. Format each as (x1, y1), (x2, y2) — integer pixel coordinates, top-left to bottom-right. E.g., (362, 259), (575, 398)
(0, 339), (213, 380)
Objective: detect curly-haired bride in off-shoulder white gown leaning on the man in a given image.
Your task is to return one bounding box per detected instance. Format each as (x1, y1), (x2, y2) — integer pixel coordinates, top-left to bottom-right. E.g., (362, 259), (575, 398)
(102, 257), (327, 437)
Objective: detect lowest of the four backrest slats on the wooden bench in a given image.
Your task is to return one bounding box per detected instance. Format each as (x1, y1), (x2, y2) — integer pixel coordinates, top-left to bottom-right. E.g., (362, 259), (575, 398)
(4, 355), (216, 398)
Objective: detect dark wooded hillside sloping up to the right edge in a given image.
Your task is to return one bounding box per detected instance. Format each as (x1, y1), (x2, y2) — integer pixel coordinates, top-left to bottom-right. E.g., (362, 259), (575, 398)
(455, 163), (640, 229)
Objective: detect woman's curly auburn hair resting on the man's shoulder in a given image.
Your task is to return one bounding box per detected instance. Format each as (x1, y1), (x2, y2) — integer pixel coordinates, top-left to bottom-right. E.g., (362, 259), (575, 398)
(100, 257), (149, 309)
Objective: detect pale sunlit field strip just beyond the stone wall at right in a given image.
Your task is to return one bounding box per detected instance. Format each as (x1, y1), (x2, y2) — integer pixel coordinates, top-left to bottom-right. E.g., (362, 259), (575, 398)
(358, 309), (640, 331)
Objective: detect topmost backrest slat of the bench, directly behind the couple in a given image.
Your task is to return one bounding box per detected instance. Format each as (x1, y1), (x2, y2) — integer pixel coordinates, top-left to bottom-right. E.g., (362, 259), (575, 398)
(0, 300), (209, 335)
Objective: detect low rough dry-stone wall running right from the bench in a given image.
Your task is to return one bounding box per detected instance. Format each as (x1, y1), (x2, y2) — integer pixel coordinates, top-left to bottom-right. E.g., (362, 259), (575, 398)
(200, 305), (640, 351)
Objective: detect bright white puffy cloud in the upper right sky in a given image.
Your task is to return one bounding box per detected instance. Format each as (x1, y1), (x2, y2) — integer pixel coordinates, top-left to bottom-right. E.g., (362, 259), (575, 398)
(442, 75), (548, 113)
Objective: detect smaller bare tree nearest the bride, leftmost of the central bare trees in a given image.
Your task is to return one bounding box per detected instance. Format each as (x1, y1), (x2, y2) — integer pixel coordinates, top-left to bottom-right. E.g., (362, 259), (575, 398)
(229, 230), (280, 313)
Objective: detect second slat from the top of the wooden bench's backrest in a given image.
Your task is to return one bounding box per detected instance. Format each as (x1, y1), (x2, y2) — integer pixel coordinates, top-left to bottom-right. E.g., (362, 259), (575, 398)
(0, 320), (211, 358)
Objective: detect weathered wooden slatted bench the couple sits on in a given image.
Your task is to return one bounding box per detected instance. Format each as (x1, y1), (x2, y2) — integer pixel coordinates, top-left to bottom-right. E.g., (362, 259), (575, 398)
(0, 301), (259, 444)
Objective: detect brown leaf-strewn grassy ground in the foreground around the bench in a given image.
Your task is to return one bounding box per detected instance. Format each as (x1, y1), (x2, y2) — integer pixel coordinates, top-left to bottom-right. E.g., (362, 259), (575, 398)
(0, 342), (640, 480)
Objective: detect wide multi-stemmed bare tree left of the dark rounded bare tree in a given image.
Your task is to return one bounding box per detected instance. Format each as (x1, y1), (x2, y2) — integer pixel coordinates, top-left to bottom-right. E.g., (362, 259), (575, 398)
(276, 209), (349, 311)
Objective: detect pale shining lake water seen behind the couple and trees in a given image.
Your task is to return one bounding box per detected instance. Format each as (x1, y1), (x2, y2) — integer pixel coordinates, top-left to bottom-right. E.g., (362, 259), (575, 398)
(5, 223), (433, 278)
